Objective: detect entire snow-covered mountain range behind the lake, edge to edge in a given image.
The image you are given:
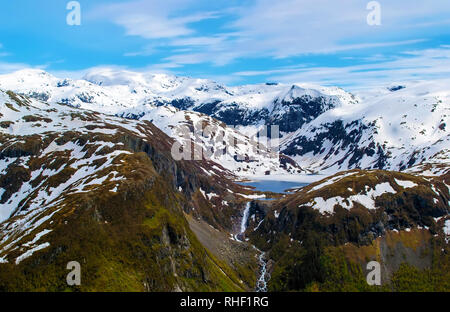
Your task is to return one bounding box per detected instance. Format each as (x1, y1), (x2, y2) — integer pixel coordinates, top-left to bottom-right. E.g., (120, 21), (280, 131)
(0, 69), (450, 174)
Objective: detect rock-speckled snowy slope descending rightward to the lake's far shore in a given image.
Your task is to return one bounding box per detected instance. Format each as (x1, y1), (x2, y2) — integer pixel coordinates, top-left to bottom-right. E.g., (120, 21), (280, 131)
(120, 105), (304, 176)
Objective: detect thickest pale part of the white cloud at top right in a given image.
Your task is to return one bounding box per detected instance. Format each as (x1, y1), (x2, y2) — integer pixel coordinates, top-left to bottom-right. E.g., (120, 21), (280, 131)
(225, 0), (450, 58)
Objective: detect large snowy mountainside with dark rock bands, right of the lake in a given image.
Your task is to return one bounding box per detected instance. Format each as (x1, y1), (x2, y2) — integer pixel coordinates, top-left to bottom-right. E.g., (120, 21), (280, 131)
(281, 81), (450, 172)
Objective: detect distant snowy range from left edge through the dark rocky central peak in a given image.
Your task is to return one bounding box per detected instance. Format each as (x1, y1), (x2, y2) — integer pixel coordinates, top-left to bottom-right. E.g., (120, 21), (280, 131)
(0, 69), (358, 128)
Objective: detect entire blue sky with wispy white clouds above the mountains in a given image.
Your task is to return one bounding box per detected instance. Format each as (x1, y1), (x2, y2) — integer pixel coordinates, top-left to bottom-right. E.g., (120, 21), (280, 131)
(0, 0), (450, 89)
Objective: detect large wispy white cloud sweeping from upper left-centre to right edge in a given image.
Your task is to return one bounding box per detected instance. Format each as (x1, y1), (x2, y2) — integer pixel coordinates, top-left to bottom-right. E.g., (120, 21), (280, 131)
(97, 0), (450, 66)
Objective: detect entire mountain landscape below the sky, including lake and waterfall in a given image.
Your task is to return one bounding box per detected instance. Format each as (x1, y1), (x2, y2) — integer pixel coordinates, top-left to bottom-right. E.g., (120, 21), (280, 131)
(0, 69), (450, 292)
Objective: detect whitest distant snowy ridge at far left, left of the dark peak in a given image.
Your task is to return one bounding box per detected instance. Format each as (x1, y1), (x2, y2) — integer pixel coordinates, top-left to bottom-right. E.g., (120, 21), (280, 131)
(0, 69), (229, 114)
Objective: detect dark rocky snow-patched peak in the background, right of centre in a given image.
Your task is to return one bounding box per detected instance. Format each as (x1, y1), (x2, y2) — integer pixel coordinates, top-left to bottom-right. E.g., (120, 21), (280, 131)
(195, 84), (357, 133)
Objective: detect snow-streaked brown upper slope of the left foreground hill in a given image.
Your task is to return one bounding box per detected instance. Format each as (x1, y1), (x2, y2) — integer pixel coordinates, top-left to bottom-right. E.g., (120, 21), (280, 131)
(0, 92), (170, 264)
